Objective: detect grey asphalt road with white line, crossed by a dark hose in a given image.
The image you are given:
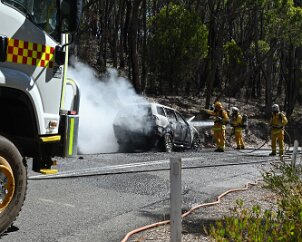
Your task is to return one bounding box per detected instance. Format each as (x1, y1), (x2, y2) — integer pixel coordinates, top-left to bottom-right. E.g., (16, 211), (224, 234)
(1, 149), (271, 242)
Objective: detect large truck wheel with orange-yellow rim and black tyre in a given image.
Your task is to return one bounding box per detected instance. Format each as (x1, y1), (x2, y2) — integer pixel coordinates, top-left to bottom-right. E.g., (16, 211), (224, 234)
(0, 136), (27, 235)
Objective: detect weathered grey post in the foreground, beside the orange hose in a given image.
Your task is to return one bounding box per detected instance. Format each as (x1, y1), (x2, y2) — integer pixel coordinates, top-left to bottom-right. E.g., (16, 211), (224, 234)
(170, 158), (182, 242)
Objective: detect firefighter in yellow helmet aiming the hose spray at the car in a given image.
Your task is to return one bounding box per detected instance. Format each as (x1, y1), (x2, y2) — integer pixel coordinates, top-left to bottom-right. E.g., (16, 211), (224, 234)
(205, 101), (229, 152)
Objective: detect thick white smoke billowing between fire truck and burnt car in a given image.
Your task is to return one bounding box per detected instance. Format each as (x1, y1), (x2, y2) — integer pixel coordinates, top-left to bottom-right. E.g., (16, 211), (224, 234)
(69, 62), (146, 154)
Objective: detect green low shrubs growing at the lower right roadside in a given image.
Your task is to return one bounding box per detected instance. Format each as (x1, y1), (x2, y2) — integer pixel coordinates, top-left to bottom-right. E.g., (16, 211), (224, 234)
(210, 160), (302, 242)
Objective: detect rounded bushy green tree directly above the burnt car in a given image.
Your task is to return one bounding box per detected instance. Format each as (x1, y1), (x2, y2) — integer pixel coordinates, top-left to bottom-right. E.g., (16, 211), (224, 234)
(147, 3), (208, 94)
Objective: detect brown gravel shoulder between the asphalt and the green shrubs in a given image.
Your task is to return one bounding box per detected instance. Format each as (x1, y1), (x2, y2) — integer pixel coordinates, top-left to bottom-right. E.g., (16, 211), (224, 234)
(128, 181), (277, 242)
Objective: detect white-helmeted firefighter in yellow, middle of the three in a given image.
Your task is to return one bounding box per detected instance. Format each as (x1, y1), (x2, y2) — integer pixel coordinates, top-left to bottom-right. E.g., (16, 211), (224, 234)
(230, 107), (244, 150)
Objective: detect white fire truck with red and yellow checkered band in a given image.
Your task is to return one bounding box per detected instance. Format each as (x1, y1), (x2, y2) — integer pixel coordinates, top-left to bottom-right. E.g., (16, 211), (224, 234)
(0, 0), (82, 234)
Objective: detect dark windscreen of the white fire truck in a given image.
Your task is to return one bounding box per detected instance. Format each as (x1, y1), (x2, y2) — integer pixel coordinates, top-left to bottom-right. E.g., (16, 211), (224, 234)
(2, 0), (60, 41)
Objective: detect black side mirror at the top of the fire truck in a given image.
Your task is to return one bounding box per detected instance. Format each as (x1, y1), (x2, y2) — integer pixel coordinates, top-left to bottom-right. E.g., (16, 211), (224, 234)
(60, 0), (83, 34)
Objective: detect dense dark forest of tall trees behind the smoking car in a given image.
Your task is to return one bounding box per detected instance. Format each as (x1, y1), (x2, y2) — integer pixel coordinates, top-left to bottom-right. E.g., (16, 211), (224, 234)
(72, 0), (302, 144)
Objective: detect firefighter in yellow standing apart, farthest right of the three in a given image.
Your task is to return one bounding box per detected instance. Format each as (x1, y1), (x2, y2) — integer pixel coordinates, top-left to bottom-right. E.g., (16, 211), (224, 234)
(269, 104), (288, 156)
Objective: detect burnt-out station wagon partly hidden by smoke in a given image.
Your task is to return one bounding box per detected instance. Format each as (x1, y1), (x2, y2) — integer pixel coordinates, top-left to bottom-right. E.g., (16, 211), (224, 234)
(113, 103), (201, 152)
